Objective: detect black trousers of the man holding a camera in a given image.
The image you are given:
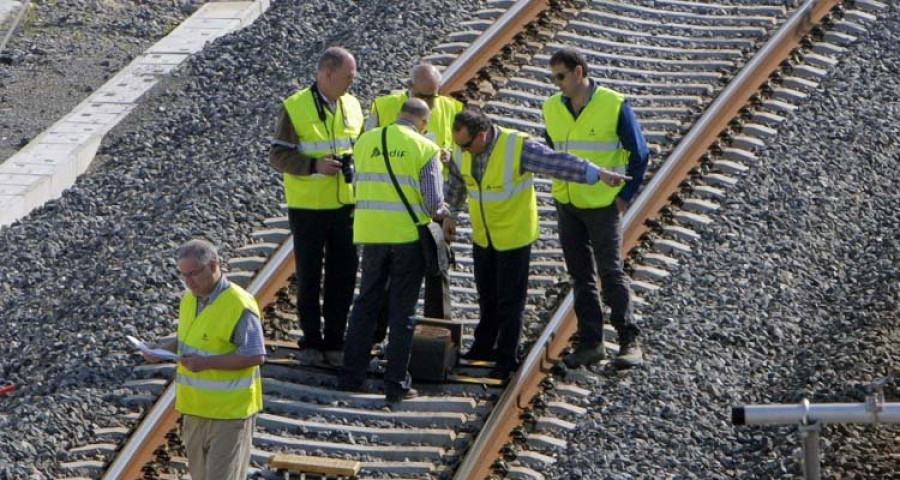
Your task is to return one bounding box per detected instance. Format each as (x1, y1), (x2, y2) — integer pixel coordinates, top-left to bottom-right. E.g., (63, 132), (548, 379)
(288, 206), (359, 351)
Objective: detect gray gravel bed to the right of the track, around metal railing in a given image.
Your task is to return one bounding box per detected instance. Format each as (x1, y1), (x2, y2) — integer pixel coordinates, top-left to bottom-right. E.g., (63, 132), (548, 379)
(544, 5), (900, 480)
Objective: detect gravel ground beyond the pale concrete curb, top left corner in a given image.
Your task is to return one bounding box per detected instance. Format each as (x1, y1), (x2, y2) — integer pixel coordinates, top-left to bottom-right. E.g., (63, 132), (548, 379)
(0, 0), (193, 162)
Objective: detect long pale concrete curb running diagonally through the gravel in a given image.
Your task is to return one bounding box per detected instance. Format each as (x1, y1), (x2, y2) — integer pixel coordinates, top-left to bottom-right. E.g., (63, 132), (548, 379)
(0, 0), (269, 227)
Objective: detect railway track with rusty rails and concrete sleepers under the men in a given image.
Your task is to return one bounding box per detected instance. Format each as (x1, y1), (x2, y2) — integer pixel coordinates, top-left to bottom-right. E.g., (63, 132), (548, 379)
(59, 0), (881, 479)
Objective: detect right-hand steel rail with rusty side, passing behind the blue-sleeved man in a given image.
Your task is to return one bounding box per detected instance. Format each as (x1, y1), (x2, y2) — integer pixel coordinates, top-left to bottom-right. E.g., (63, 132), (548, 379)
(453, 0), (840, 480)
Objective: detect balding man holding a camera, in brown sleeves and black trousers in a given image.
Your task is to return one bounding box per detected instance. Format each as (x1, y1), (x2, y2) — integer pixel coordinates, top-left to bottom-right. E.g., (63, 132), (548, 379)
(269, 47), (364, 366)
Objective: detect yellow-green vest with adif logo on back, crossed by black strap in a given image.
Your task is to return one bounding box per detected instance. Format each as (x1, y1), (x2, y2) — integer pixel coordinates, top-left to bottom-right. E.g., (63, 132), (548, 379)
(353, 125), (440, 244)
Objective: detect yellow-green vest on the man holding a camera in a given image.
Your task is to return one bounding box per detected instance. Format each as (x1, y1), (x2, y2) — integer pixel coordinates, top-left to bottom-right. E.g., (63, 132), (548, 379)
(283, 88), (363, 210)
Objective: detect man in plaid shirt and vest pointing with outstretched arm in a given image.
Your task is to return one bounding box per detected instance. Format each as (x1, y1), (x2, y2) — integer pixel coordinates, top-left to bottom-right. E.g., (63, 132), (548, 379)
(444, 110), (624, 380)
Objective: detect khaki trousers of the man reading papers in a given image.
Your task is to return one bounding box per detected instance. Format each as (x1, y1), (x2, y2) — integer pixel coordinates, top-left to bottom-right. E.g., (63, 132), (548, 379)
(181, 415), (256, 480)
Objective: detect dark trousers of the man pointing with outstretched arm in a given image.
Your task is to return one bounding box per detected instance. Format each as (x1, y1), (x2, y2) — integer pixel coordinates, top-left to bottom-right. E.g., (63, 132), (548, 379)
(470, 244), (531, 370)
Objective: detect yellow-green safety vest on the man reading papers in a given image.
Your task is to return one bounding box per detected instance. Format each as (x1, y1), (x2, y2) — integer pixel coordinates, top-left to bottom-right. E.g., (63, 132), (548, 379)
(175, 283), (262, 420)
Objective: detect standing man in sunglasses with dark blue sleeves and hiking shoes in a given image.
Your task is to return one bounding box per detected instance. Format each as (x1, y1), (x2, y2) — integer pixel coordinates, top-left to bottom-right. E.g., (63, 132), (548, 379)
(542, 49), (649, 368)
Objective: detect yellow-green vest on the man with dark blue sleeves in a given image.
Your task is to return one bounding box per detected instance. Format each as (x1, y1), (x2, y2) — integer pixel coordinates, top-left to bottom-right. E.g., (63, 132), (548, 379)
(542, 87), (629, 208)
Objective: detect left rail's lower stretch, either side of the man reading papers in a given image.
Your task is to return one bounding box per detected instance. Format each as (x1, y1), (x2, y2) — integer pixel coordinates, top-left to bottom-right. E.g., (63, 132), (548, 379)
(103, 236), (295, 480)
